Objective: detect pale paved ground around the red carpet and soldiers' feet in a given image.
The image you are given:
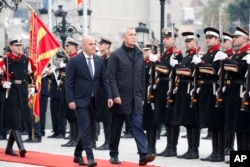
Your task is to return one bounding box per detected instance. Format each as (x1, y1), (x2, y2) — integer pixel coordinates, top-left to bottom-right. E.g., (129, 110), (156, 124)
(0, 130), (229, 167)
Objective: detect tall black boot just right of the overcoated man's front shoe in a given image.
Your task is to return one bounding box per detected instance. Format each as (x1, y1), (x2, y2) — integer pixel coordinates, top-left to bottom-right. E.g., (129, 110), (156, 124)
(163, 126), (180, 157)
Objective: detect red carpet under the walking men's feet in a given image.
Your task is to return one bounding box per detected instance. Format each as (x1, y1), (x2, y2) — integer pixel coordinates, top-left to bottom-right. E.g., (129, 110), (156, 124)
(0, 149), (156, 167)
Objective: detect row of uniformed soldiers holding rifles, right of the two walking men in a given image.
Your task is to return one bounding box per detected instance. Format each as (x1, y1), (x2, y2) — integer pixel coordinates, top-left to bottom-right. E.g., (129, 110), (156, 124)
(143, 24), (250, 163)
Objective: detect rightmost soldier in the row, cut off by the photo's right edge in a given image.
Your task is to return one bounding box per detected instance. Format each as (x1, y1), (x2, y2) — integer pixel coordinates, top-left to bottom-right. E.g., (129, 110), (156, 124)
(221, 27), (250, 164)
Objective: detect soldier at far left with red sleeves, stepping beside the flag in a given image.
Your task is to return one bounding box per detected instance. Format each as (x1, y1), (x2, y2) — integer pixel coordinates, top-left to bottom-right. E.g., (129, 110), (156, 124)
(0, 36), (33, 157)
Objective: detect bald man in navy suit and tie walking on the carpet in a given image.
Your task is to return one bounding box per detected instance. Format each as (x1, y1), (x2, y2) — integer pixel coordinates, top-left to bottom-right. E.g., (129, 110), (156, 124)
(65, 36), (113, 167)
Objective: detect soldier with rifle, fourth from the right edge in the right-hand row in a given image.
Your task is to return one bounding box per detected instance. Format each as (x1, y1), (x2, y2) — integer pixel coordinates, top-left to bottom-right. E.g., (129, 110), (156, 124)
(170, 32), (200, 159)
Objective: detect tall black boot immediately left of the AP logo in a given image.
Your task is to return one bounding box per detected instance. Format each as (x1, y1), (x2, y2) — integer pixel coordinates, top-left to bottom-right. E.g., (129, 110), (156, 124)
(211, 130), (225, 162)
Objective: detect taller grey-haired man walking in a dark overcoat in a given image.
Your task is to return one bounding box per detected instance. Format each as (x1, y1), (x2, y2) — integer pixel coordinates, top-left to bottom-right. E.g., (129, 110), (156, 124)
(107, 28), (155, 166)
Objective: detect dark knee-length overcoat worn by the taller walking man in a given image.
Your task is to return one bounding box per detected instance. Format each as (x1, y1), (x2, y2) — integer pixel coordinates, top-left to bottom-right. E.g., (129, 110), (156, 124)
(107, 44), (145, 114)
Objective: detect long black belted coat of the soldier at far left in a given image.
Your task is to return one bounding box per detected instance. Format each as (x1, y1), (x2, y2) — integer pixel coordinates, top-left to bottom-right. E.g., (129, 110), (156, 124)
(3, 55), (29, 130)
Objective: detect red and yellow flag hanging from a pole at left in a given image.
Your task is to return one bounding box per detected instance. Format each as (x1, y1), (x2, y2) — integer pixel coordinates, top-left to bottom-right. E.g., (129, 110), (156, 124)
(30, 12), (60, 121)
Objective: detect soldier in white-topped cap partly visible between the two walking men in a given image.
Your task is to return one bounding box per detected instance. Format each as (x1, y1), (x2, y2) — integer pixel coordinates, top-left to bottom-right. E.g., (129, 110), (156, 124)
(96, 36), (112, 150)
